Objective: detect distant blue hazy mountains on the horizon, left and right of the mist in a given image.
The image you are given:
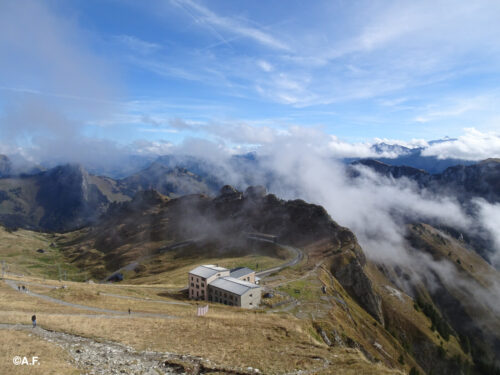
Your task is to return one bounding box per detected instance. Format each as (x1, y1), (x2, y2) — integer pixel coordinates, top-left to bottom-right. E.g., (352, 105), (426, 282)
(0, 154), (500, 231)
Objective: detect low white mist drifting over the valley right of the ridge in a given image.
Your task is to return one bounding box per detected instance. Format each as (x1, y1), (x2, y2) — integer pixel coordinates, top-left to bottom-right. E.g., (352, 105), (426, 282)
(159, 134), (500, 324)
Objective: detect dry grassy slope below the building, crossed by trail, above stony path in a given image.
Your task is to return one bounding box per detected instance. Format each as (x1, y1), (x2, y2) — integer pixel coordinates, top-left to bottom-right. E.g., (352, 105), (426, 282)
(0, 280), (397, 374)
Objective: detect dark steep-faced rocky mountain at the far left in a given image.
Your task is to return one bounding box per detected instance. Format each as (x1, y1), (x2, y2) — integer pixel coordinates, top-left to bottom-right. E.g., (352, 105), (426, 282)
(0, 165), (129, 231)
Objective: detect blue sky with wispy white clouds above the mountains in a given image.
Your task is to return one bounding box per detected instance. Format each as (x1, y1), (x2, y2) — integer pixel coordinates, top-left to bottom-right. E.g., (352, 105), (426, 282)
(0, 0), (500, 164)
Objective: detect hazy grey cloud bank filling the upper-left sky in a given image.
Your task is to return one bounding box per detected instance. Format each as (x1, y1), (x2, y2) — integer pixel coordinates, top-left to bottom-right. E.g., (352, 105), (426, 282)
(0, 0), (123, 169)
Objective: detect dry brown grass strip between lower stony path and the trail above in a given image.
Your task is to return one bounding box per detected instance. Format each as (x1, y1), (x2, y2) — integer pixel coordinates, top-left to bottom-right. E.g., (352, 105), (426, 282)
(0, 312), (398, 374)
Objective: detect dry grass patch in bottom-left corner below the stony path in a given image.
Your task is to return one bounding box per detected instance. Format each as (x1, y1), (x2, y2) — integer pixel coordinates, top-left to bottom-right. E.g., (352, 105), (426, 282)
(0, 329), (80, 375)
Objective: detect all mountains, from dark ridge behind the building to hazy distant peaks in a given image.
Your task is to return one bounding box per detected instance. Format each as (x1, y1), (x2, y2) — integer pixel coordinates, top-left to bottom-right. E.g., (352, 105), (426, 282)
(0, 154), (500, 374)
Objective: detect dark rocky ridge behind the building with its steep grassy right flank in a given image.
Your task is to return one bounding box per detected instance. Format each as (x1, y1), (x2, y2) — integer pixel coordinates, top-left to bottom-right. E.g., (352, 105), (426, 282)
(47, 186), (499, 374)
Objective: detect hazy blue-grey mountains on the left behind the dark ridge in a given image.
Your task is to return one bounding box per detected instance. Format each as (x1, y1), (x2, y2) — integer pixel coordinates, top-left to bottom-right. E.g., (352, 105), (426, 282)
(0, 164), (213, 232)
